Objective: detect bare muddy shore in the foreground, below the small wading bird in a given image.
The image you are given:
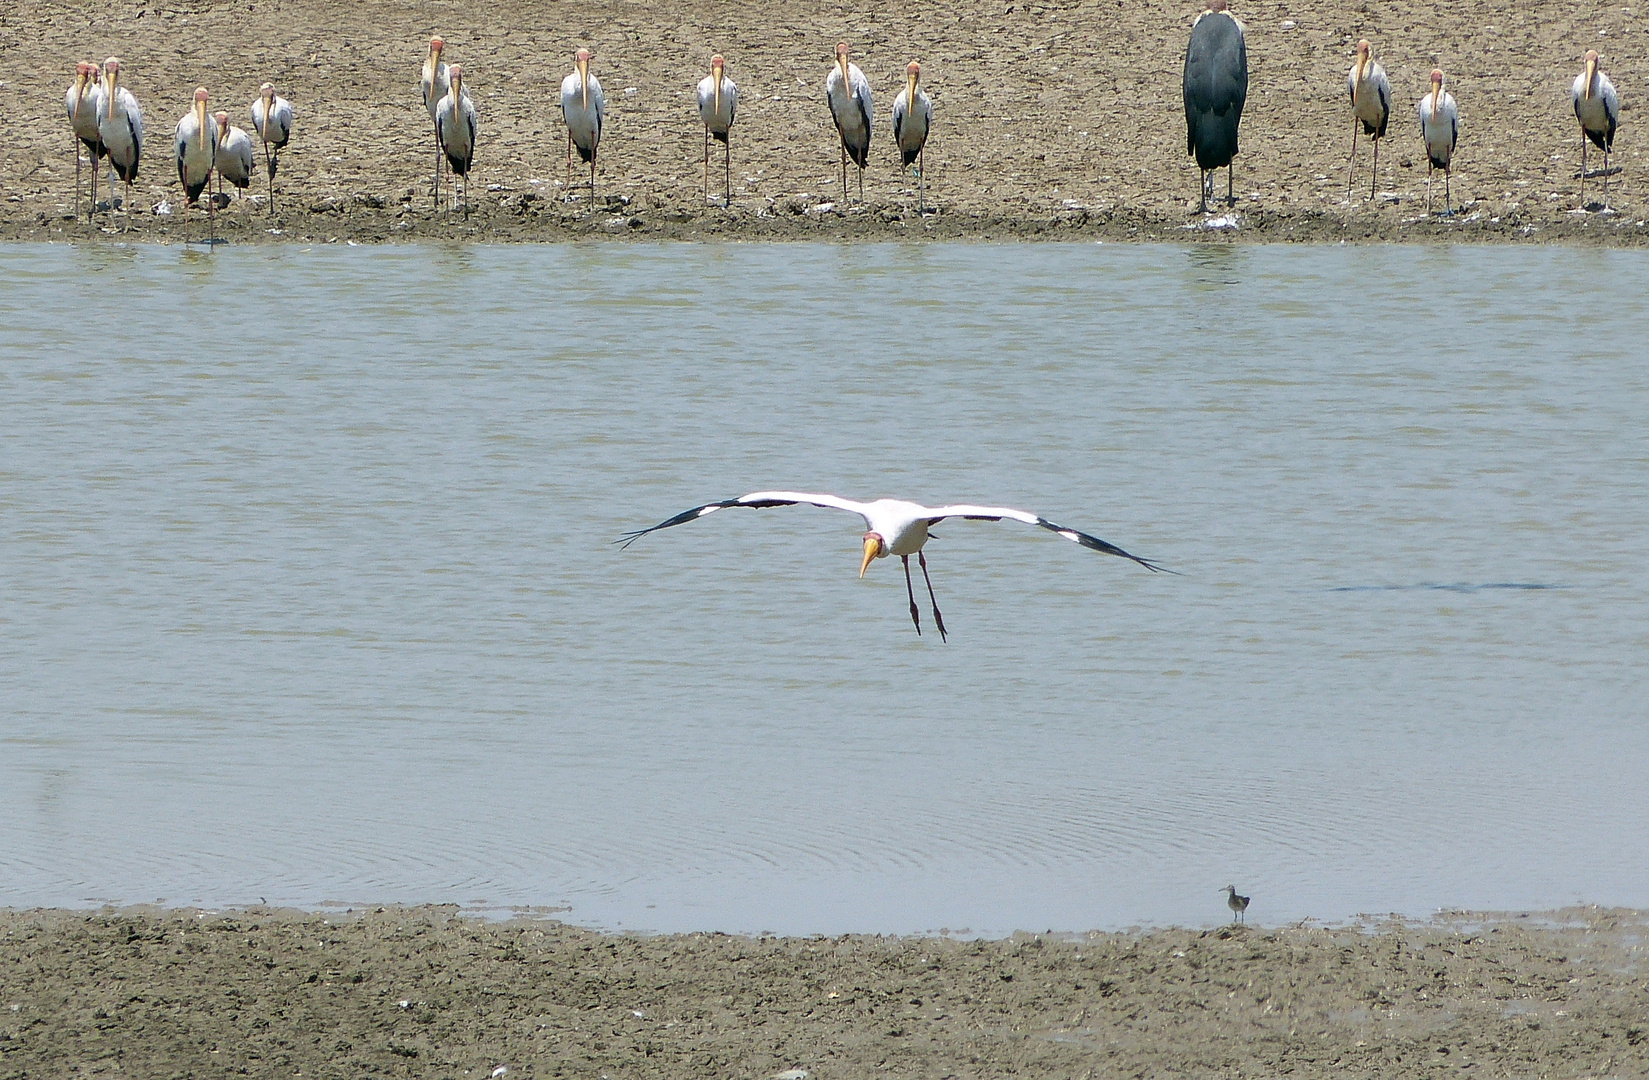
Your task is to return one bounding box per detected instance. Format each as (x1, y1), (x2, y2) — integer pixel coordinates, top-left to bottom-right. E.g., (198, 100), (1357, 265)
(0, 907), (1649, 1080)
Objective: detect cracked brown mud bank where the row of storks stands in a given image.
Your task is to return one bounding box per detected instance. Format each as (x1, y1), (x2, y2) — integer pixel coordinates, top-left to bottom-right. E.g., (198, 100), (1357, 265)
(0, 0), (1649, 244)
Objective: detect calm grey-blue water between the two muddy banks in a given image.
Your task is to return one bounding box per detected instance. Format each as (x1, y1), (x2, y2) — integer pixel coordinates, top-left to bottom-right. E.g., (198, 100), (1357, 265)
(0, 244), (1649, 933)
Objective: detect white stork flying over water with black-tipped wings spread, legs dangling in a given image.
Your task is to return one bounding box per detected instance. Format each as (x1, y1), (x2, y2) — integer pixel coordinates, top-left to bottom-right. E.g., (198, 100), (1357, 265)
(615, 491), (1172, 641)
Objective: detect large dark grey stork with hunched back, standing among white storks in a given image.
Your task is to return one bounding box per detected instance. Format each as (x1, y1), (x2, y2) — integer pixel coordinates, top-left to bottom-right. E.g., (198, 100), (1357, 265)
(1184, 0), (1248, 213)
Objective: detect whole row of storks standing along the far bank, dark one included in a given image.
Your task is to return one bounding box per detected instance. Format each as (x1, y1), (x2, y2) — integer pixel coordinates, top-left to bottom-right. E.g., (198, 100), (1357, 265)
(66, 0), (1619, 237)
